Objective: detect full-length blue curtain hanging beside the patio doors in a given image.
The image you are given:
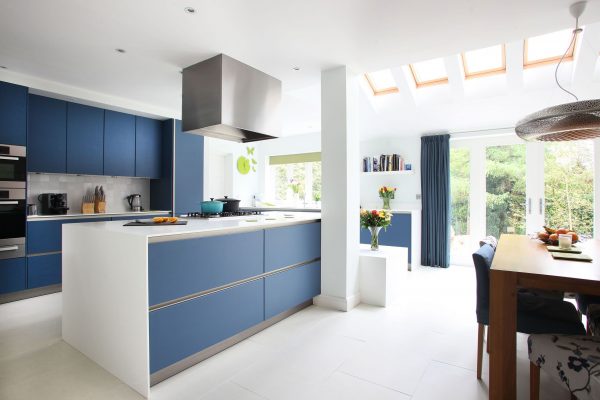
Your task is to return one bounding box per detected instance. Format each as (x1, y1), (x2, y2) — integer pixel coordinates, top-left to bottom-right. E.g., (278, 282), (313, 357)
(421, 135), (450, 268)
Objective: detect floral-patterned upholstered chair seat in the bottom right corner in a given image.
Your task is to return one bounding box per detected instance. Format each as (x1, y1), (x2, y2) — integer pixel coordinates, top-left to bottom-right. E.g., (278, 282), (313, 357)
(528, 335), (600, 399)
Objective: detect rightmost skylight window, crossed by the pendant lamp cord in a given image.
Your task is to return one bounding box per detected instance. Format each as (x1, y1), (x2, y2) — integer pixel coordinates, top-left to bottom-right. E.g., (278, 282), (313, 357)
(523, 29), (576, 68)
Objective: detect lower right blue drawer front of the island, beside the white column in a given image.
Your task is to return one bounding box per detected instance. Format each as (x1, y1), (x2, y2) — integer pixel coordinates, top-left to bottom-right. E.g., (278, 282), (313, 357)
(265, 261), (321, 319)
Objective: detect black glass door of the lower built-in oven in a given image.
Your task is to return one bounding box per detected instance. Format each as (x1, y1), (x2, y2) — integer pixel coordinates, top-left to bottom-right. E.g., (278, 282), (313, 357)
(0, 189), (27, 240)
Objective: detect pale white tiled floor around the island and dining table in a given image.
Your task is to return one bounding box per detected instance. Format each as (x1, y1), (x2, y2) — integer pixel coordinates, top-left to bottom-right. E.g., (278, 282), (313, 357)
(0, 267), (569, 400)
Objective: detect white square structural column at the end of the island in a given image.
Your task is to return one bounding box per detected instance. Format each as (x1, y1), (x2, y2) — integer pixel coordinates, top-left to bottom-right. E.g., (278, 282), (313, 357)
(315, 67), (360, 311)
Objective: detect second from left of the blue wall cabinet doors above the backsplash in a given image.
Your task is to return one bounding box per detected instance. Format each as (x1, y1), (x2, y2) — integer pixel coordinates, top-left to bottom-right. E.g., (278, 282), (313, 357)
(67, 103), (104, 175)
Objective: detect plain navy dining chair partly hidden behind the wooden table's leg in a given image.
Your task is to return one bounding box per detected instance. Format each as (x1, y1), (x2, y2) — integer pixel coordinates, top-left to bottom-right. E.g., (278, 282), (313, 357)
(473, 244), (585, 379)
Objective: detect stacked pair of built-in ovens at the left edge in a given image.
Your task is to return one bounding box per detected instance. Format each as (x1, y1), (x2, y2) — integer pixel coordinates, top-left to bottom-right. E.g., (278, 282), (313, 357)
(0, 144), (27, 259)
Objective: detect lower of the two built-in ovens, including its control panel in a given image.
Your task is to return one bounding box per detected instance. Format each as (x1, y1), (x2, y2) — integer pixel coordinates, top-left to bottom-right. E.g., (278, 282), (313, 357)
(0, 187), (27, 259)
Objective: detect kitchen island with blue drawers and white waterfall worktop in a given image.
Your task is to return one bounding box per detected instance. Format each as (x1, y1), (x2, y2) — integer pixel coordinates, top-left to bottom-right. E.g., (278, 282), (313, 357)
(62, 213), (321, 397)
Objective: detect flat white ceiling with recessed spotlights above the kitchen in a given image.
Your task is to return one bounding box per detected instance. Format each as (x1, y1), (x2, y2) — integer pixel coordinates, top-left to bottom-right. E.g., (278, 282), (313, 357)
(0, 0), (600, 138)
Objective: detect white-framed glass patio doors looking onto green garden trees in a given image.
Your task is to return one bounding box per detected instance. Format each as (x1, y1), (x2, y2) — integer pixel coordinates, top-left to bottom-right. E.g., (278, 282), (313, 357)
(450, 135), (594, 265)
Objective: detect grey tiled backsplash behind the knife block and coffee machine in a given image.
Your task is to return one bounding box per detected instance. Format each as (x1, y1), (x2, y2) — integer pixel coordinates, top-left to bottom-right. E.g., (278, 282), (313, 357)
(27, 174), (150, 214)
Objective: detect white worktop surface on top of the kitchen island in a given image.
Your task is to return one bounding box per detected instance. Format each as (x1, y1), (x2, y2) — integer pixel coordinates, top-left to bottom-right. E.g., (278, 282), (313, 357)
(63, 212), (321, 242)
